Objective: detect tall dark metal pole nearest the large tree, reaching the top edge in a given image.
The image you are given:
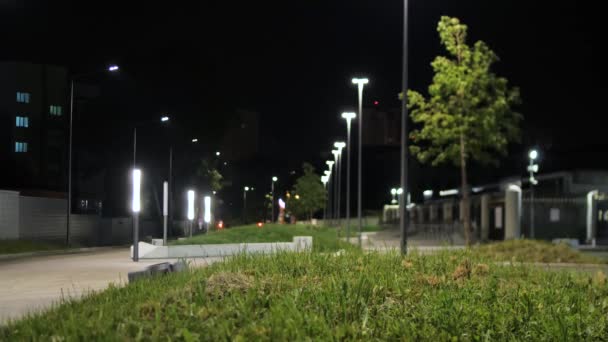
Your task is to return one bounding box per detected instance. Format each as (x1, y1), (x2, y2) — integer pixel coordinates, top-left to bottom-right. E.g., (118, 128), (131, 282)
(399, 0), (410, 254)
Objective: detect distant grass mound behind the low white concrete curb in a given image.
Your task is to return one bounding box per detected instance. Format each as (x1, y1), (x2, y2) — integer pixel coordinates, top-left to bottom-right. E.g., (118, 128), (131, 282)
(171, 224), (354, 252)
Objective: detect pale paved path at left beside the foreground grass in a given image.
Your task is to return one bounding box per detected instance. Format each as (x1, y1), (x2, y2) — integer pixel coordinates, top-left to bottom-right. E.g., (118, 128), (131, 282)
(0, 248), (221, 323)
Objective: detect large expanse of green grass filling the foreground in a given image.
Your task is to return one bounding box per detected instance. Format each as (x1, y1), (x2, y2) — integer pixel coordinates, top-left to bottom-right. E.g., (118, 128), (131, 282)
(0, 251), (608, 341)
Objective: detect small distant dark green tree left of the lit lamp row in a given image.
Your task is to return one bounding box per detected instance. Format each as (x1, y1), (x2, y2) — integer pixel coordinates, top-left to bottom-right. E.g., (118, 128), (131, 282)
(287, 163), (327, 220)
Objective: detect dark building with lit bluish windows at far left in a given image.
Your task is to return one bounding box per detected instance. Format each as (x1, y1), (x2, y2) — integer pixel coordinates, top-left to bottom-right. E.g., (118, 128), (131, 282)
(0, 62), (69, 191)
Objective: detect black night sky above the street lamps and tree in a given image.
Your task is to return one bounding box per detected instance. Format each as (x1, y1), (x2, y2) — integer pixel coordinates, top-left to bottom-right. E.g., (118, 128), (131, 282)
(0, 0), (608, 208)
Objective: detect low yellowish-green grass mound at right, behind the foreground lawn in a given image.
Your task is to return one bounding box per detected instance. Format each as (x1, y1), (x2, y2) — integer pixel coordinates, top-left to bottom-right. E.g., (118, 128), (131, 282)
(474, 240), (606, 264)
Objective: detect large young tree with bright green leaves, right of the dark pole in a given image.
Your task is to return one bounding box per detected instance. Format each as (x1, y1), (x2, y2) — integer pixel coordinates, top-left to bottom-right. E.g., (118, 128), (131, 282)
(408, 17), (522, 245)
